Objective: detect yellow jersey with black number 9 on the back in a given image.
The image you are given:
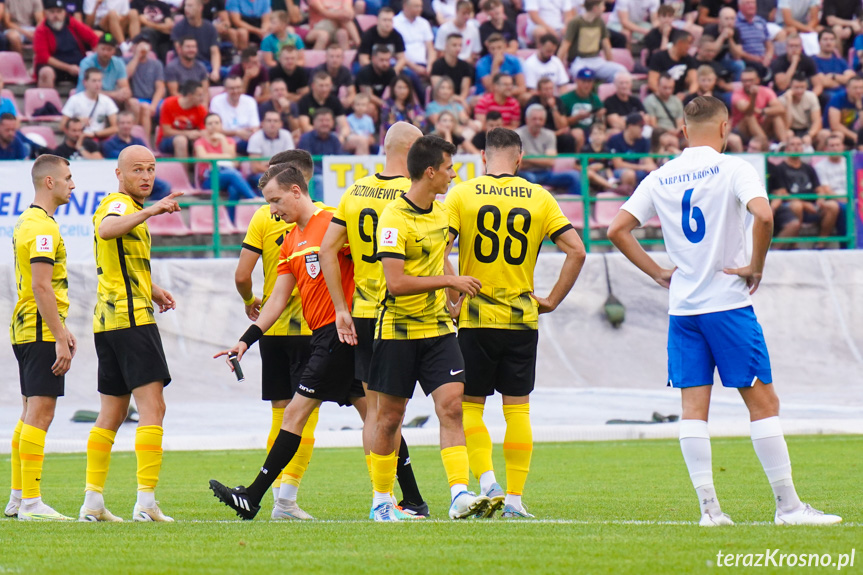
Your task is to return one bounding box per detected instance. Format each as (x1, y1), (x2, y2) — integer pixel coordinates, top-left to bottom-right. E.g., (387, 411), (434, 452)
(333, 174), (411, 317)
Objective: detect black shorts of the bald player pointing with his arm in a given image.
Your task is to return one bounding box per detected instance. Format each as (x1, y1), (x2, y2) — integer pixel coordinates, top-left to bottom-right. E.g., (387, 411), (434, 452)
(93, 323), (171, 396)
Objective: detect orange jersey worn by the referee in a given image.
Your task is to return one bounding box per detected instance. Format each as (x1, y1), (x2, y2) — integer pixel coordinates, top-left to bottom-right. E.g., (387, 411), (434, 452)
(278, 208), (354, 331)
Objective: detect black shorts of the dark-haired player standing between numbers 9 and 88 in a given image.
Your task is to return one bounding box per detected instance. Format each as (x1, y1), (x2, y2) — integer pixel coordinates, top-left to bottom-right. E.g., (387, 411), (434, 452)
(368, 333), (464, 398)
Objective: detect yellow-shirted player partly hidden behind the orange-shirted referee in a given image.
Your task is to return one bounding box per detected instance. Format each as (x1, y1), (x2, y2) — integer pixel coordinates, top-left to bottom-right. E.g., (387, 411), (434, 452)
(234, 150), (323, 520)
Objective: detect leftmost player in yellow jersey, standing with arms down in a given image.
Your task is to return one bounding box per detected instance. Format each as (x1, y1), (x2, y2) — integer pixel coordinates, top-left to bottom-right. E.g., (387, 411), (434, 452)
(5, 154), (76, 521)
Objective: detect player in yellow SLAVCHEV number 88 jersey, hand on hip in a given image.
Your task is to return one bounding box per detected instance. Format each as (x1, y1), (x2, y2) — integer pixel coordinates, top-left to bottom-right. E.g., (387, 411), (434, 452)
(446, 128), (585, 518)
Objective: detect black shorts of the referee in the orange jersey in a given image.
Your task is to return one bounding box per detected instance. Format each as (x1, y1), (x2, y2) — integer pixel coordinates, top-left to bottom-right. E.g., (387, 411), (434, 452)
(296, 323), (365, 405)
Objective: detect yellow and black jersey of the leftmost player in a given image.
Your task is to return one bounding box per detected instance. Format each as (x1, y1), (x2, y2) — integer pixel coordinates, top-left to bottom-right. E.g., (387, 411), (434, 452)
(9, 205), (69, 344)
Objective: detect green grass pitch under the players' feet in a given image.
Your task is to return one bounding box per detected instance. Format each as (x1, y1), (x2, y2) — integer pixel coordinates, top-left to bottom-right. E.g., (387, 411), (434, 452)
(0, 436), (863, 575)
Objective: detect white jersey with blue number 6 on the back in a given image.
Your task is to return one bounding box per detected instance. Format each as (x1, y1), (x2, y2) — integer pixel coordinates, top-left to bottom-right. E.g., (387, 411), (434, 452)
(621, 146), (767, 315)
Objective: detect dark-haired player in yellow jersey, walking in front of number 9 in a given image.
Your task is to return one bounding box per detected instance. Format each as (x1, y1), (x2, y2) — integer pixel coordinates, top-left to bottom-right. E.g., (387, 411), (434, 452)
(368, 136), (489, 521)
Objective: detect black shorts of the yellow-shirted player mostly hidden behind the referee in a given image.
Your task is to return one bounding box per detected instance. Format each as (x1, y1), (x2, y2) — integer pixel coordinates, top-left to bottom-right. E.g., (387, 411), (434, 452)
(259, 335), (312, 401)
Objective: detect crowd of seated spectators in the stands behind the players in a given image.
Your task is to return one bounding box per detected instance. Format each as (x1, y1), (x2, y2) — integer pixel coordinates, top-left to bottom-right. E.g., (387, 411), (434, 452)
(0, 0), (852, 241)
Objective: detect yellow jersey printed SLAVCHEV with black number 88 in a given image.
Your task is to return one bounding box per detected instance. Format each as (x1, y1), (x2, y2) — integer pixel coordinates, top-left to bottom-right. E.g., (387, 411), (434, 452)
(445, 175), (572, 329)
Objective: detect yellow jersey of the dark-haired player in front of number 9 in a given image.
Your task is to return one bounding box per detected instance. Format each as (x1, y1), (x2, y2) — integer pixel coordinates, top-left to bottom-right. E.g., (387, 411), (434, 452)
(375, 196), (455, 339)
